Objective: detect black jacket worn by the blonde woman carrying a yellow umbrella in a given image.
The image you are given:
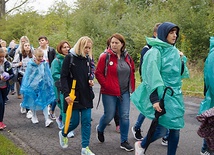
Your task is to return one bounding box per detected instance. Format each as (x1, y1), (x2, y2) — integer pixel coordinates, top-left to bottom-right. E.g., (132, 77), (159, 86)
(60, 54), (94, 111)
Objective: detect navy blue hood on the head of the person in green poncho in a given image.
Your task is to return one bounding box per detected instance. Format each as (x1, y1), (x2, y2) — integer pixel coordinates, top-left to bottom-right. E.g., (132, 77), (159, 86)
(157, 22), (179, 42)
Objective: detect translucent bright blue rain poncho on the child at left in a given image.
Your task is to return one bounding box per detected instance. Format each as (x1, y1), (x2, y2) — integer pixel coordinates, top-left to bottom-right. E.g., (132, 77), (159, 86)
(20, 59), (55, 110)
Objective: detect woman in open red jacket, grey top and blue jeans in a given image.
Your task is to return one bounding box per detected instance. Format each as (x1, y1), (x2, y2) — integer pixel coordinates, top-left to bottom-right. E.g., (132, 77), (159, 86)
(95, 33), (135, 151)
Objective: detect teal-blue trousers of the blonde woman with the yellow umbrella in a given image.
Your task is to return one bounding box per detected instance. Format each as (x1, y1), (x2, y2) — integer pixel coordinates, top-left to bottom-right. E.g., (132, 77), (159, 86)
(62, 109), (91, 148)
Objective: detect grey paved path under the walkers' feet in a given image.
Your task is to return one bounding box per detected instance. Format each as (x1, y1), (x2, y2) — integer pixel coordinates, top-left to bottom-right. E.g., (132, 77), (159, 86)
(0, 84), (202, 155)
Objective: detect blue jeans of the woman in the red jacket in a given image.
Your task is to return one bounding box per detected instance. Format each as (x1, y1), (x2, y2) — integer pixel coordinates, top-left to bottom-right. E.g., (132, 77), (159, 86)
(98, 91), (130, 143)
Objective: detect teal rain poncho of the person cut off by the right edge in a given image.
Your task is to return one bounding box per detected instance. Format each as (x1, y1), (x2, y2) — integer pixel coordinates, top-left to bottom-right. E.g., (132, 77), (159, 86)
(198, 37), (214, 114)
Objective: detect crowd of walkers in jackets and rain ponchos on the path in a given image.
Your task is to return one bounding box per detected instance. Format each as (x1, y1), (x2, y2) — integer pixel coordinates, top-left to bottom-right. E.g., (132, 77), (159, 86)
(0, 22), (211, 155)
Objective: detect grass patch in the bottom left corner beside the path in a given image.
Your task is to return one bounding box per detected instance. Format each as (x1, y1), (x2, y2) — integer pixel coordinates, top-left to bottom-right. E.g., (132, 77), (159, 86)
(0, 134), (26, 155)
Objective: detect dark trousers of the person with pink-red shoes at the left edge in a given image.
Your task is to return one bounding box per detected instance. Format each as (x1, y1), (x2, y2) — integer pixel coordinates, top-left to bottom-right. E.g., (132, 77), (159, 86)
(0, 88), (7, 122)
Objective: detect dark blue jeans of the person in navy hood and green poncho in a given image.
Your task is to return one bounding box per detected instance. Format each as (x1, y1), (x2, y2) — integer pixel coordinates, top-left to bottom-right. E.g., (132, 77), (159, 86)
(141, 124), (180, 155)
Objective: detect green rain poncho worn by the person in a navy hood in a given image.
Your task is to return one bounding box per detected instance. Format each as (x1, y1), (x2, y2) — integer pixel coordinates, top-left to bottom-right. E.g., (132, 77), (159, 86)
(131, 38), (189, 129)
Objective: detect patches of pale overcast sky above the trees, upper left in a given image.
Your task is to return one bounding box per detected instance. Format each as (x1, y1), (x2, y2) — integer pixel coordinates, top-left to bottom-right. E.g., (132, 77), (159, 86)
(6, 0), (76, 13)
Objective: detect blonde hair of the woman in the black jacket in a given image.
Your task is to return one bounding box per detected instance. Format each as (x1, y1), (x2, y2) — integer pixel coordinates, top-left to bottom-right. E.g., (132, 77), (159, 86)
(74, 36), (93, 59)
